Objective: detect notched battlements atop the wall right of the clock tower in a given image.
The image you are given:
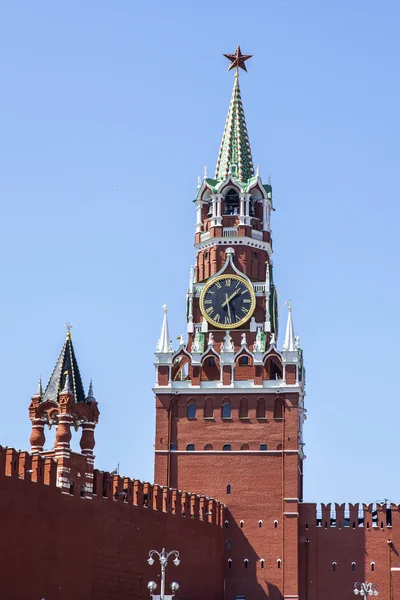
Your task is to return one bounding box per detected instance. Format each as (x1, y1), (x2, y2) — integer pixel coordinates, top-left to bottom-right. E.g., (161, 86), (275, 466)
(301, 500), (400, 530)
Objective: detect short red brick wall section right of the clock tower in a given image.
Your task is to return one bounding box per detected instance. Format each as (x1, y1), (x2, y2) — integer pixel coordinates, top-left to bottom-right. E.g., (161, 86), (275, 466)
(299, 504), (400, 600)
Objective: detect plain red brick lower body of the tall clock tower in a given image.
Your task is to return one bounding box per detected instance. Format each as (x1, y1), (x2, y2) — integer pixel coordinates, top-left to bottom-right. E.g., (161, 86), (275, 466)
(155, 390), (299, 600)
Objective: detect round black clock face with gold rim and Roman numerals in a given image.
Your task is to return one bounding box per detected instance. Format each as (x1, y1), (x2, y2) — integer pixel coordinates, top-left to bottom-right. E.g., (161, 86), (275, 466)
(200, 275), (256, 329)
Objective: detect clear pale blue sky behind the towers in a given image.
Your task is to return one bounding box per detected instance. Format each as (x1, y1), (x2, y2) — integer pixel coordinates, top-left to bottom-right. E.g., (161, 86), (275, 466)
(0, 0), (400, 502)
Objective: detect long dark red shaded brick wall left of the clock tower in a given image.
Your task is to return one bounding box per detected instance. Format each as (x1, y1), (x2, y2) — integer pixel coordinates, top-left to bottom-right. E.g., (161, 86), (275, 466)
(0, 448), (223, 600)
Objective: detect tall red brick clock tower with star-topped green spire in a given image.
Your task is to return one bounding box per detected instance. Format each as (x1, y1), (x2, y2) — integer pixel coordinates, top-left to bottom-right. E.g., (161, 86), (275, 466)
(155, 48), (304, 600)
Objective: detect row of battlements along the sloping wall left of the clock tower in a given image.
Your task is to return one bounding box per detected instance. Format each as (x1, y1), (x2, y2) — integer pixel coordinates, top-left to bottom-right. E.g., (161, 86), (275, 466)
(0, 446), (225, 527)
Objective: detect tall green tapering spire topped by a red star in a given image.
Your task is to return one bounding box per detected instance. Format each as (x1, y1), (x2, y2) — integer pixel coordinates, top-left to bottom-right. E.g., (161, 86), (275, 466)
(215, 46), (254, 181)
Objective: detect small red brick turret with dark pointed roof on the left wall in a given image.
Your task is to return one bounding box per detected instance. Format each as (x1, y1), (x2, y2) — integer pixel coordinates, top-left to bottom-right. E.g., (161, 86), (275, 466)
(29, 329), (100, 496)
